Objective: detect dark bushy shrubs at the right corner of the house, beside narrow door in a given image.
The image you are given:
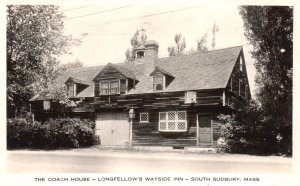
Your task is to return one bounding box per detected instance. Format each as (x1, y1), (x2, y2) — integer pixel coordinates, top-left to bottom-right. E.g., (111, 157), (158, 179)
(217, 101), (292, 155)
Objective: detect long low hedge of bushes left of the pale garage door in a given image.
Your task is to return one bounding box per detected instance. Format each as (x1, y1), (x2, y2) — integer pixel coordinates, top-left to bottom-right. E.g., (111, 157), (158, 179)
(7, 118), (99, 149)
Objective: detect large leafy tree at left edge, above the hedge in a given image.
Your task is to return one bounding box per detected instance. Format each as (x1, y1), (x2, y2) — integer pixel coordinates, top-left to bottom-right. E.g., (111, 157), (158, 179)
(6, 5), (80, 117)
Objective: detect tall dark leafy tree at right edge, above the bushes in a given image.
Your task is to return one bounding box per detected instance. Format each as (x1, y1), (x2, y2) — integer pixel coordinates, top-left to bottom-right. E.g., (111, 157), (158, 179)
(239, 6), (293, 154)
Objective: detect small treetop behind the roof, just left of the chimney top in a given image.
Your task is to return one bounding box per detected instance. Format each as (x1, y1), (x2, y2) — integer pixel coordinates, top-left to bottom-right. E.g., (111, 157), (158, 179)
(125, 28), (147, 62)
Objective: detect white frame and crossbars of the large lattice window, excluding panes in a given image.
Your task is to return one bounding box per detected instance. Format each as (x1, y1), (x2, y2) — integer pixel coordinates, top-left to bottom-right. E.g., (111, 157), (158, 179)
(158, 111), (187, 132)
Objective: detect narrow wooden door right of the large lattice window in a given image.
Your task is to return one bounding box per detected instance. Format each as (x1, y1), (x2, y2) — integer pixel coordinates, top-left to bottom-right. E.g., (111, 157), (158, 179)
(198, 114), (211, 145)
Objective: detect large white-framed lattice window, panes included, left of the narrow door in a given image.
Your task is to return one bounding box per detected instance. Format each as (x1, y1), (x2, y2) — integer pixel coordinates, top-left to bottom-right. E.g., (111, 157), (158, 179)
(158, 111), (187, 132)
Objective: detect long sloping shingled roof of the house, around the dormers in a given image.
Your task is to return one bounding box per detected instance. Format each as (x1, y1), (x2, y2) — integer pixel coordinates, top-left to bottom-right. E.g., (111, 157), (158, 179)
(29, 46), (242, 97)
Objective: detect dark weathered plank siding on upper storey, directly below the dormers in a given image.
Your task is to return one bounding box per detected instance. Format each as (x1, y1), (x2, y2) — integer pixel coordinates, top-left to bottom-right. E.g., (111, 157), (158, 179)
(95, 90), (222, 109)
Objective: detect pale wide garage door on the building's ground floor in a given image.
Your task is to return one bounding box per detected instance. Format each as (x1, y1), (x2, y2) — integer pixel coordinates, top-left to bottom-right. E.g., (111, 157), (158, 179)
(96, 112), (130, 146)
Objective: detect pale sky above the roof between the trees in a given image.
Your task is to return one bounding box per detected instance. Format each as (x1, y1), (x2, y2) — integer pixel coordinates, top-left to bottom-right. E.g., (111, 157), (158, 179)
(60, 2), (255, 95)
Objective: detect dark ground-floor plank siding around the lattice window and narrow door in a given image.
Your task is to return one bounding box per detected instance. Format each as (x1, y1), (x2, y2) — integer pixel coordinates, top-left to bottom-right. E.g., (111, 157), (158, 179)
(133, 110), (221, 147)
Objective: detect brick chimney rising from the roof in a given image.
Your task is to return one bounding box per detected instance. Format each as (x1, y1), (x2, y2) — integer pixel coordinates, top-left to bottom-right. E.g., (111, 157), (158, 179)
(144, 40), (159, 76)
